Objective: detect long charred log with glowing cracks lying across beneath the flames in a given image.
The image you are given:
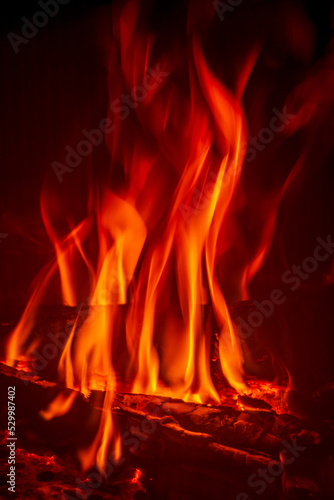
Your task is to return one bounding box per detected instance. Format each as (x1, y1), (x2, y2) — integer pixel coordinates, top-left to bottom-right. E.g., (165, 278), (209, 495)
(0, 365), (334, 465)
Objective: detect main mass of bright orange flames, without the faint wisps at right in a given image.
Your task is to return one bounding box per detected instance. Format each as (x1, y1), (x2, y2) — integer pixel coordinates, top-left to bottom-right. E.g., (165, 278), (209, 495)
(8, 1), (256, 424)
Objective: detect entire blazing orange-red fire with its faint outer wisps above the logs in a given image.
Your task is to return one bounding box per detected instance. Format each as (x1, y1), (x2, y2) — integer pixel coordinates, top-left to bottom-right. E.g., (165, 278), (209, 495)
(7, 0), (320, 468)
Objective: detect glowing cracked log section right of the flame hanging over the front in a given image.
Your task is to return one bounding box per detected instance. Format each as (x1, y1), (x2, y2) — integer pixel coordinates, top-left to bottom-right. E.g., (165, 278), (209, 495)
(116, 394), (331, 457)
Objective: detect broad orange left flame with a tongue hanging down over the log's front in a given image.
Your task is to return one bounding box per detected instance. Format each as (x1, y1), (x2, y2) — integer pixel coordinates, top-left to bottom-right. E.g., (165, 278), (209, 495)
(59, 192), (146, 470)
